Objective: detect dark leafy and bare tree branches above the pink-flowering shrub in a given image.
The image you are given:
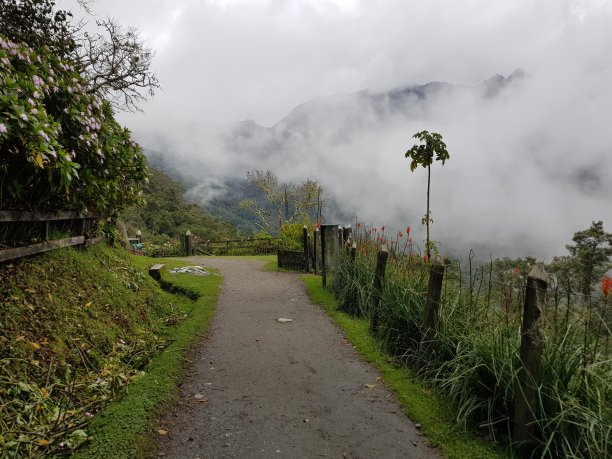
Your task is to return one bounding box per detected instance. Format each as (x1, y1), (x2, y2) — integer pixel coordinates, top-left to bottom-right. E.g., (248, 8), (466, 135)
(0, 0), (160, 110)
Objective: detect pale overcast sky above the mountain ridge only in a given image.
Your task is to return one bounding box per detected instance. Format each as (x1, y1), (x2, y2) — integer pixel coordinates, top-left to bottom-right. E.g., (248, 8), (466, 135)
(67, 0), (612, 125)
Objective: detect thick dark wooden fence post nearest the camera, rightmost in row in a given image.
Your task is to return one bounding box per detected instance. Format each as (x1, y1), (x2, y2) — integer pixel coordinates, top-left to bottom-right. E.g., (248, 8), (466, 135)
(513, 265), (548, 449)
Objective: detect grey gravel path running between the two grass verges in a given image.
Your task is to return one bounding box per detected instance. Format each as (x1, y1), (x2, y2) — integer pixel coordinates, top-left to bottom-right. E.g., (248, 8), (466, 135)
(159, 258), (440, 459)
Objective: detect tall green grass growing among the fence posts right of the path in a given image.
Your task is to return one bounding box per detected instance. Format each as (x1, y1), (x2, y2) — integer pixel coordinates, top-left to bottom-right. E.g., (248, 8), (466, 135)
(333, 222), (612, 458)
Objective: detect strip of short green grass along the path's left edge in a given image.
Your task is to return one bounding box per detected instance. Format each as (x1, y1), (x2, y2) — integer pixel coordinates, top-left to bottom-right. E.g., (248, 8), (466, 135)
(74, 257), (221, 458)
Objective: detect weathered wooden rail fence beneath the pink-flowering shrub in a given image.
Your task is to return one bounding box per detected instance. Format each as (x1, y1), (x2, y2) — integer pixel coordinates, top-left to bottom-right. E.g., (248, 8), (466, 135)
(0, 210), (102, 262)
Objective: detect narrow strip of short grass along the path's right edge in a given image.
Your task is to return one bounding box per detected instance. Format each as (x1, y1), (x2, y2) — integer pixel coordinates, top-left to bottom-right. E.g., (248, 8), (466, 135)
(302, 274), (511, 459)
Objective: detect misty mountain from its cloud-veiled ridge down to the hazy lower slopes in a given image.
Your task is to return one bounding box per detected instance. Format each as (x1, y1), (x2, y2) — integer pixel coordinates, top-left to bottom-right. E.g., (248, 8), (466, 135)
(146, 70), (524, 237)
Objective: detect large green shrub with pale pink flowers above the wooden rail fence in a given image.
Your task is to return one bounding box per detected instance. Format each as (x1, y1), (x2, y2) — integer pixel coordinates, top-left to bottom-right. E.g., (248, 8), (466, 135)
(0, 35), (147, 213)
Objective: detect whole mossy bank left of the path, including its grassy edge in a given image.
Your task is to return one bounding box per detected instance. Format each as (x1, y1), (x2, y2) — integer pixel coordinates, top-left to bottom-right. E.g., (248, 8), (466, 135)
(0, 244), (221, 457)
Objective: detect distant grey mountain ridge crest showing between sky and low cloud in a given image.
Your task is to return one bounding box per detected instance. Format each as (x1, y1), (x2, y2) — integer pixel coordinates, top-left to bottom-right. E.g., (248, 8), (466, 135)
(222, 69), (525, 160)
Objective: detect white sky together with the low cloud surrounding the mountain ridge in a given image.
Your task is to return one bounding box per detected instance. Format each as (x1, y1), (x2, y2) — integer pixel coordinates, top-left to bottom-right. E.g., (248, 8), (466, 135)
(58, 0), (612, 257)
